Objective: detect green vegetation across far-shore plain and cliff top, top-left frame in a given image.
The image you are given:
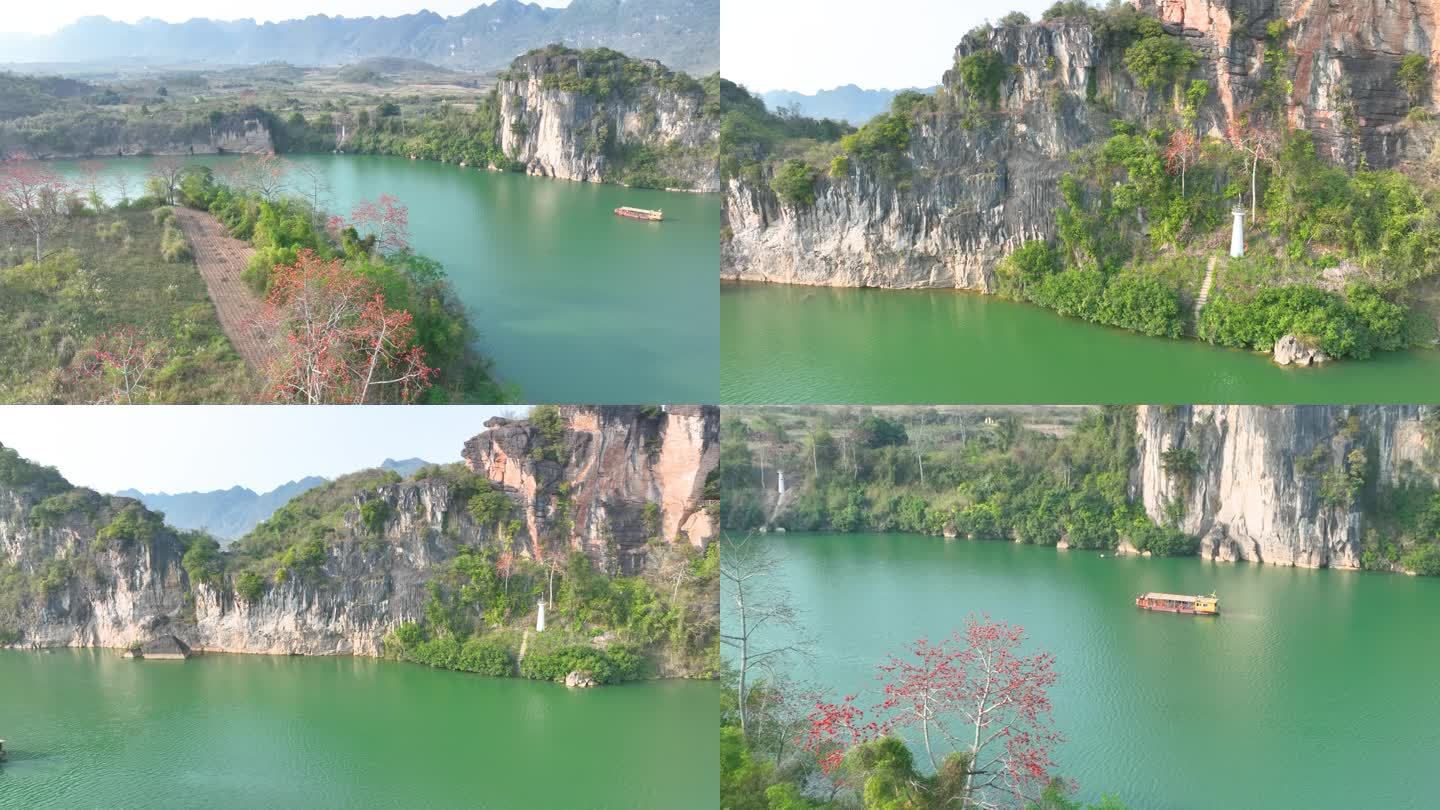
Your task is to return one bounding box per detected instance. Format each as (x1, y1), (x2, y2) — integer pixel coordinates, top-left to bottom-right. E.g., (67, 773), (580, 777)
(0, 45), (720, 194)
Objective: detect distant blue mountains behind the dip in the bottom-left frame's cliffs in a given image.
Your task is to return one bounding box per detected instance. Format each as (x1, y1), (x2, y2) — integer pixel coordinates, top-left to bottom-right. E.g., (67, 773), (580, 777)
(115, 458), (426, 542)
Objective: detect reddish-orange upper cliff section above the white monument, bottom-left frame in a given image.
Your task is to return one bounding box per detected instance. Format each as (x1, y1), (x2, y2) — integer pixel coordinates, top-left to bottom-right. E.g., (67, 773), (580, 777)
(464, 405), (720, 571)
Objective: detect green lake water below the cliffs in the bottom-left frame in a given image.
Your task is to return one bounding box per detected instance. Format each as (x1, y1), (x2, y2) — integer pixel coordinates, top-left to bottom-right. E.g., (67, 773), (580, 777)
(0, 650), (720, 810)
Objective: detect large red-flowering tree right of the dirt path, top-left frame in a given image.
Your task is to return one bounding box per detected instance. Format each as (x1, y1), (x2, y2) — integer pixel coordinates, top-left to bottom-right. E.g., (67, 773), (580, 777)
(259, 251), (439, 405)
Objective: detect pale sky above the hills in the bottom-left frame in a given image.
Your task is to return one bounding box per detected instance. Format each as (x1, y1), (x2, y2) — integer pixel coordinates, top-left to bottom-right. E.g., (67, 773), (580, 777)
(0, 405), (527, 493)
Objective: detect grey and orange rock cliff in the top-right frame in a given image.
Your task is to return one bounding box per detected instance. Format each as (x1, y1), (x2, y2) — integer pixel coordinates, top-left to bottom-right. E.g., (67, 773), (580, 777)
(721, 0), (1440, 291)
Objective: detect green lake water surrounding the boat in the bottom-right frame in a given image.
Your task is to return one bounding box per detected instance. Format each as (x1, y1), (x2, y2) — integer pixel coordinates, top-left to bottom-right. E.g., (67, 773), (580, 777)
(748, 535), (1440, 810)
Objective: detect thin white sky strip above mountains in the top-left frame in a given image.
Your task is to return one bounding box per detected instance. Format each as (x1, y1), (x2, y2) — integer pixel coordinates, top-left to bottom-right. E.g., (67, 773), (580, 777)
(0, 0), (570, 33)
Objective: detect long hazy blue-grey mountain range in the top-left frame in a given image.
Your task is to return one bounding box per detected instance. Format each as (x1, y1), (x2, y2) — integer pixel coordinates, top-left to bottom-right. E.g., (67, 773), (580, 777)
(0, 0), (720, 74)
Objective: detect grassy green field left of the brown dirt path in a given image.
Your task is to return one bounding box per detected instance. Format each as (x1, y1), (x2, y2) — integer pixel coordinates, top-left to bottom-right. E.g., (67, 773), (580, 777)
(0, 205), (259, 404)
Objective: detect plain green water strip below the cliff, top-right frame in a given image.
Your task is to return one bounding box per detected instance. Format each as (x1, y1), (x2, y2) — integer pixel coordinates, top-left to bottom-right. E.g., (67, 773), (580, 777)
(720, 284), (1440, 404)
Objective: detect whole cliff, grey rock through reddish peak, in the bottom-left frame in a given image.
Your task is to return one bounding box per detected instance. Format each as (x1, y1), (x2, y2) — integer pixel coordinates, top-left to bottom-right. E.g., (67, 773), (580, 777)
(0, 406), (719, 657)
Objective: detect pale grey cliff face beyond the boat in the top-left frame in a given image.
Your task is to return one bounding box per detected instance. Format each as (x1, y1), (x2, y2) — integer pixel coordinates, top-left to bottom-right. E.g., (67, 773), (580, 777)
(498, 52), (720, 192)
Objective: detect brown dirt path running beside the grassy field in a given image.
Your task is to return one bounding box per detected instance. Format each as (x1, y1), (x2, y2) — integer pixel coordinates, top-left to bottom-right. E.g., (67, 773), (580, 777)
(174, 206), (269, 373)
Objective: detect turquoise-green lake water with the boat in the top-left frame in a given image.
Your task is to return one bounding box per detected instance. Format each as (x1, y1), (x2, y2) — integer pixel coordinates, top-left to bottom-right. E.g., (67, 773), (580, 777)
(56, 154), (720, 402)
